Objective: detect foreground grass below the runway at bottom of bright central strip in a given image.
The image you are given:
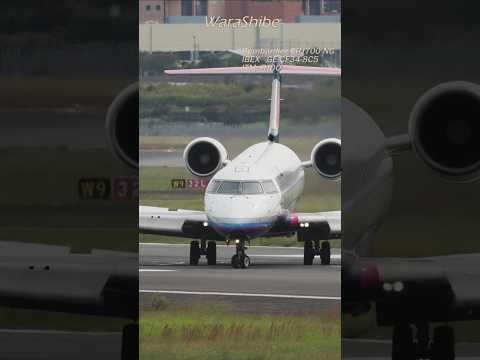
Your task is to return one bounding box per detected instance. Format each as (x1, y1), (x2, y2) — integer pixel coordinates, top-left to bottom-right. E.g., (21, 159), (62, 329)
(140, 307), (341, 360)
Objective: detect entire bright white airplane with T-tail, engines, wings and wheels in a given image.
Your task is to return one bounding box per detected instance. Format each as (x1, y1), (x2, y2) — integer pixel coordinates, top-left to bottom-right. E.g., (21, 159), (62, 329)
(139, 59), (341, 268)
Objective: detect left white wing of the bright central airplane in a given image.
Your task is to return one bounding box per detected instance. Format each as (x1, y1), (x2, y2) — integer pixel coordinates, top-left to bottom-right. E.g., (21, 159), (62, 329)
(138, 206), (223, 240)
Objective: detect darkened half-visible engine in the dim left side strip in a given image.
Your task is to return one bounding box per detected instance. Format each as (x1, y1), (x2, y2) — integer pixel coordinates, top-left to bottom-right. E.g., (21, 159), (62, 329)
(106, 83), (139, 168)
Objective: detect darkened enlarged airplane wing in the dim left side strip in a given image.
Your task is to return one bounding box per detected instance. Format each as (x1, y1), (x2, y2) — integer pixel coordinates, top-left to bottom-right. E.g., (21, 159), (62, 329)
(0, 241), (138, 319)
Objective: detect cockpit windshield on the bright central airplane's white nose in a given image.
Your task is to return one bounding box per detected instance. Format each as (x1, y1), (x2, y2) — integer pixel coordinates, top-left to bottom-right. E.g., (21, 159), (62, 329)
(207, 180), (278, 195)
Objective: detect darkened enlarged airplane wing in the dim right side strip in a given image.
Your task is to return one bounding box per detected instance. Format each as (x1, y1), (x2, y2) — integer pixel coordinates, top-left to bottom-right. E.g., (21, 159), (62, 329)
(356, 254), (480, 325)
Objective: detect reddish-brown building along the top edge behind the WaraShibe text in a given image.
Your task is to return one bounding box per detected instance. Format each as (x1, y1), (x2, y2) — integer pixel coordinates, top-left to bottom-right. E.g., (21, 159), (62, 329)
(139, 0), (341, 23)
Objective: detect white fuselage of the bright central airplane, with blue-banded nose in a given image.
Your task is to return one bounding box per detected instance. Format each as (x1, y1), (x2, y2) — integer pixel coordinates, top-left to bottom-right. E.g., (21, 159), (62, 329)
(205, 141), (304, 240)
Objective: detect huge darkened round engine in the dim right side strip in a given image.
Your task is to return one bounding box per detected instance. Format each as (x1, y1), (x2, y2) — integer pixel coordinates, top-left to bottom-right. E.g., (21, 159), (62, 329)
(409, 81), (480, 181)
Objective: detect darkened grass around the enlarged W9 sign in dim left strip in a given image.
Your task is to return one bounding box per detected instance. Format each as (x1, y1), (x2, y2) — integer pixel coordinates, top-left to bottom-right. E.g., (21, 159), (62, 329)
(0, 147), (138, 252)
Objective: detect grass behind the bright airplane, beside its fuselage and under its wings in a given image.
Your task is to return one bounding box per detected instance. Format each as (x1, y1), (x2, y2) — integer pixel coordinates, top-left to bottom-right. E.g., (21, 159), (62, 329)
(139, 167), (341, 247)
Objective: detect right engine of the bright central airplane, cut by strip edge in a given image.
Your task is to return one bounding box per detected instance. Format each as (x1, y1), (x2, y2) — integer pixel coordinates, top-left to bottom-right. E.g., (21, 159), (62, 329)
(310, 138), (342, 180)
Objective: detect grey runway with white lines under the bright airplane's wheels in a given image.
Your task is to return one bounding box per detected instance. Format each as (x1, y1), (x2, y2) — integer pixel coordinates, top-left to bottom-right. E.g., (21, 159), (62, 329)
(139, 243), (340, 313)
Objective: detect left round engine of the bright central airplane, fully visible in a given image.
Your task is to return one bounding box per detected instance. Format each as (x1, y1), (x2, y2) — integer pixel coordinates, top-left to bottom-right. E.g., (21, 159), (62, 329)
(183, 137), (227, 177)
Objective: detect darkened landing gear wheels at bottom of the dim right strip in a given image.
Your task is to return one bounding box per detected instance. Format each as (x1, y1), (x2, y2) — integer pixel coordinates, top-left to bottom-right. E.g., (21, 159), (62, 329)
(392, 323), (455, 360)
